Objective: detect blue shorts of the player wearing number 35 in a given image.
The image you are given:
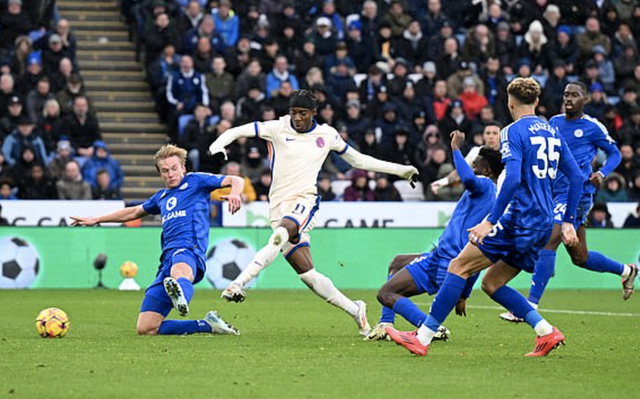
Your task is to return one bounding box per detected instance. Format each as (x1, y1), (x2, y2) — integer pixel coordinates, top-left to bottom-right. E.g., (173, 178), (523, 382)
(478, 223), (553, 273)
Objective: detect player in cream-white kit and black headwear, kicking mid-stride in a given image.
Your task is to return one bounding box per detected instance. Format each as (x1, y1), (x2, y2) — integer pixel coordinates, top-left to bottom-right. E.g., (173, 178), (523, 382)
(209, 90), (418, 336)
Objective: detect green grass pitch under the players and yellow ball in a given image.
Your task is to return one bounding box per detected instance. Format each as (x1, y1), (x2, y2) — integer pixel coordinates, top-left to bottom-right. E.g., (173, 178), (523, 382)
(0, 290), (640, 399)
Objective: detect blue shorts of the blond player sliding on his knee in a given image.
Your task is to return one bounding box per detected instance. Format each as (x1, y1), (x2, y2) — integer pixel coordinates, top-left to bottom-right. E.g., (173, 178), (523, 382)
(140, 248), (207, 317)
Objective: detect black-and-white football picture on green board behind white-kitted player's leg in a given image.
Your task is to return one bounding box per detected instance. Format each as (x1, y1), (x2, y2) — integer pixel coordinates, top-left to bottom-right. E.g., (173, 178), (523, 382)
(207, 239), (256, 289)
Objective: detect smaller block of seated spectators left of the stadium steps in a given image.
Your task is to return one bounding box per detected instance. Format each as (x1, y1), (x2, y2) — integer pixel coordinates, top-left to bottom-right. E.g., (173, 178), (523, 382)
(0, 0), (123, 199)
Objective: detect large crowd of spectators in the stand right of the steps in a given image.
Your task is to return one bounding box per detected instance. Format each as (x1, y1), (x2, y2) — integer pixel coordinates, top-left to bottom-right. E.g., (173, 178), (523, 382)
(122, 0), (640, 206)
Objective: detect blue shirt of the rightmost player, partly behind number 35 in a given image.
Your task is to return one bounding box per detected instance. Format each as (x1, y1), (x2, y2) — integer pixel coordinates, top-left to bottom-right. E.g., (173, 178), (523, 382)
(549, 114), (617, 194)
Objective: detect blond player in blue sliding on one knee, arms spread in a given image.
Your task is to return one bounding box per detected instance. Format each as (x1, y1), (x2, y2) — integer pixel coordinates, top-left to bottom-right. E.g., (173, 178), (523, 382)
(71, 144), (244, 335)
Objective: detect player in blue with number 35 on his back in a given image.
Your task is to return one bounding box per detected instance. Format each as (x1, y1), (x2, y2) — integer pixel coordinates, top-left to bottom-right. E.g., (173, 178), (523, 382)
(387, 78), (582, 356)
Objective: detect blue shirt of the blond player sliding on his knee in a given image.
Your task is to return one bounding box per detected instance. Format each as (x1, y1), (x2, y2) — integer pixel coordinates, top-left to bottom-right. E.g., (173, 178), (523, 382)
(142, 173), (225, 257)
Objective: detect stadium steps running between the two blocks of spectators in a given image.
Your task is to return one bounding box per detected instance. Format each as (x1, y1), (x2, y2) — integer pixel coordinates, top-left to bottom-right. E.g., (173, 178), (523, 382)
(58, 0), (167, 201)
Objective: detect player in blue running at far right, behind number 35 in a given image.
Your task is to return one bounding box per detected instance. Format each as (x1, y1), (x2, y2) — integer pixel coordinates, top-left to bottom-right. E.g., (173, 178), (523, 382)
(500, 82), (638, 323)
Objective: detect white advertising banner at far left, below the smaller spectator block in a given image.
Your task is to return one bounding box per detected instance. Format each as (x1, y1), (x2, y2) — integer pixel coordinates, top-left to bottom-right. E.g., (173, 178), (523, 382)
(0, 200), (124, 226)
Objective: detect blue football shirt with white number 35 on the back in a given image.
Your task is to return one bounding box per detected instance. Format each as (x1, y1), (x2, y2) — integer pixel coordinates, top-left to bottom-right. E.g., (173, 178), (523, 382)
(500, 115), (573, 231)
